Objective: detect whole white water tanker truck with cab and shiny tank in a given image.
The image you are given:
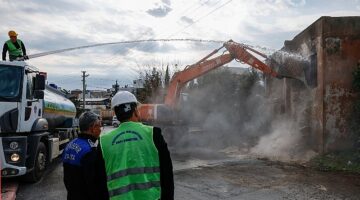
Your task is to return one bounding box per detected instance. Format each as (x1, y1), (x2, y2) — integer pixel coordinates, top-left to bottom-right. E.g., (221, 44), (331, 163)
(0, 61), (78, 182)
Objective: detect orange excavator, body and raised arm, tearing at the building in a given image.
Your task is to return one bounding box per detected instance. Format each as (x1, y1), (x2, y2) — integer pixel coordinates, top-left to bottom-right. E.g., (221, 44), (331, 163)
(139, 40), (282, 124)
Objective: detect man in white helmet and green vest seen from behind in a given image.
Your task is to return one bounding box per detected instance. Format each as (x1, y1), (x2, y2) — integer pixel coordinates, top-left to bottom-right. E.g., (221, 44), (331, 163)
(98, 91), (174, 200)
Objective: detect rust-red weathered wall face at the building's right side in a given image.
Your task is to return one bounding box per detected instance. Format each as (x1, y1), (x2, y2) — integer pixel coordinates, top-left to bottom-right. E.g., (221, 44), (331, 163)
(322, 17), (360, 151)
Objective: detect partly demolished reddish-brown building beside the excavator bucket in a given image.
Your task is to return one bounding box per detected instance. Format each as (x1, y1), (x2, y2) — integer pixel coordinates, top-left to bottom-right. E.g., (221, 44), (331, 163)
(267, 17), (360, 152)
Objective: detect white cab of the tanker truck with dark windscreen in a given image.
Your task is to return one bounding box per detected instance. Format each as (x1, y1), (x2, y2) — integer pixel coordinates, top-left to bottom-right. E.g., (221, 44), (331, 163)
(0, 61), (76, 181)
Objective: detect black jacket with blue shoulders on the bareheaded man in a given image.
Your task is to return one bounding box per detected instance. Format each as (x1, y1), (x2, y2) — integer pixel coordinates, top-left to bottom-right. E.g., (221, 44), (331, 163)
(62, 134), (107, 200)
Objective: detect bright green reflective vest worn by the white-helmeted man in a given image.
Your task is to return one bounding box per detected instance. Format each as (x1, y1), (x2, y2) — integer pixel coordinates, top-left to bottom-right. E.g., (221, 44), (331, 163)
(100, 122), (161, 200)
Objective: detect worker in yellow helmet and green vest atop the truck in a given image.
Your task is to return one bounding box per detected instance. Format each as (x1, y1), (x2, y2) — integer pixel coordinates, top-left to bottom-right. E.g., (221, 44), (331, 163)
(2, 31), (28, 61)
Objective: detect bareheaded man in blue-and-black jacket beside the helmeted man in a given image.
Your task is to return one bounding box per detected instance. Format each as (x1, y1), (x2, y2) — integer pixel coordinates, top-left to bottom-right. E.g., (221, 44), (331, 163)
(62, 112), (107, 200)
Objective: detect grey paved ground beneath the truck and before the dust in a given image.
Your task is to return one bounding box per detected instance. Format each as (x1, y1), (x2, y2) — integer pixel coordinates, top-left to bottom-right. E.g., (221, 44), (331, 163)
(12, 128), (360, 200)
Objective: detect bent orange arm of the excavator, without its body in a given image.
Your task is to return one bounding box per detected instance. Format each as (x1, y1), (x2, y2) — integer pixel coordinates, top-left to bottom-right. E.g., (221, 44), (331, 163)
(165, 40), (280, 108)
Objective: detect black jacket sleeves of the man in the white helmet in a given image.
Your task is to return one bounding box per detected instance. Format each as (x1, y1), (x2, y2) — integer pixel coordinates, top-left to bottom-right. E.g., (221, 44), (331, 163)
(97, 127), (174, 200)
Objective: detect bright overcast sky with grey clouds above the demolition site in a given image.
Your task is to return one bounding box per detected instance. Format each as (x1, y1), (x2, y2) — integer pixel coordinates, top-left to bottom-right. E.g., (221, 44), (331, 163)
(0, 0), (360, 89)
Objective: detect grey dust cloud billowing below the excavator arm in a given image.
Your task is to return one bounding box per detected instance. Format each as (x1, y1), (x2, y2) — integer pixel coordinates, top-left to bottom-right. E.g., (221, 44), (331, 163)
(174, 62), (316, 162)
